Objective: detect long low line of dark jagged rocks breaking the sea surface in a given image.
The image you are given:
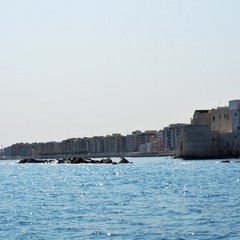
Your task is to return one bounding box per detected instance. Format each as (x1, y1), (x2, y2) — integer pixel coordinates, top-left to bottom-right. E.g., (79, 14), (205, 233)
(18, 157), (132, 164)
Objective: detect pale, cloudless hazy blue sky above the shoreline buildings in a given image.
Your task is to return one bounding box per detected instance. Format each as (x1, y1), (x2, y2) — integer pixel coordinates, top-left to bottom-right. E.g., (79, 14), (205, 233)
(0, 0), (240, 147)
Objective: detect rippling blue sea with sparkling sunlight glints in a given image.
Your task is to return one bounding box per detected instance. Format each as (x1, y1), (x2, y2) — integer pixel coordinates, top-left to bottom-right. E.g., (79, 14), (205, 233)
(0, 157), (240, 240)
